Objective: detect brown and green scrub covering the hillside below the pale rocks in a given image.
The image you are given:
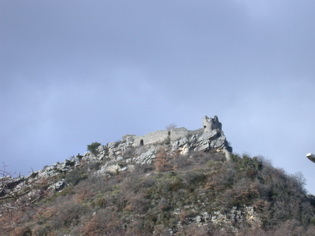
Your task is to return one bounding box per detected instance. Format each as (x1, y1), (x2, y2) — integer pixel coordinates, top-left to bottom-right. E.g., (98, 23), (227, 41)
(0, 147), (315, 236)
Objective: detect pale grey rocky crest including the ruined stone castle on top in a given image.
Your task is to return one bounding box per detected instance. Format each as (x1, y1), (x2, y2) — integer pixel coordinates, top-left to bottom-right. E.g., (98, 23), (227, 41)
(0, 116), (232, 206)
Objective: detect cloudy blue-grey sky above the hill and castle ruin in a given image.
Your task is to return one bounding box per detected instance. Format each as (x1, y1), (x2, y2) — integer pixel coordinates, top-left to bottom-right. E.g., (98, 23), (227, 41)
(0, 0), (315, 194)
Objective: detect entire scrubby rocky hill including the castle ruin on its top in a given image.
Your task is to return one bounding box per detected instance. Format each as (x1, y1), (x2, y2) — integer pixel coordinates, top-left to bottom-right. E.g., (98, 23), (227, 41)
(0, 116), (315, 235)
